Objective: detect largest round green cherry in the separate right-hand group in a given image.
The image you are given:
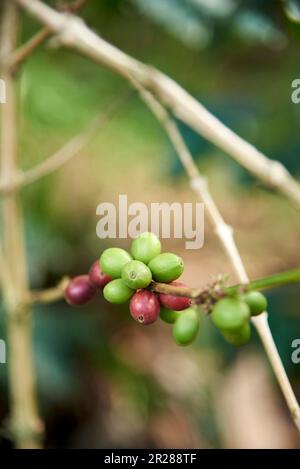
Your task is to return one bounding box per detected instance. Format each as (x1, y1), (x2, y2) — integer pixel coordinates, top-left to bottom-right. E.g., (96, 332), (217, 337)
(211, 298), (250, 331)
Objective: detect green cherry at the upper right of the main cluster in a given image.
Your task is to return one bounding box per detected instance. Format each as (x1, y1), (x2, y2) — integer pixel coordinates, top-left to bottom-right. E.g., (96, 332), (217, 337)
(148, 252), (184, 283)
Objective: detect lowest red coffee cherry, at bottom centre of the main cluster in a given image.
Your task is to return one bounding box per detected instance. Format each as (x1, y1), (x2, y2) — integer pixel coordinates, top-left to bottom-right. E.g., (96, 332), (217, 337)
(130, 290), (160, 325)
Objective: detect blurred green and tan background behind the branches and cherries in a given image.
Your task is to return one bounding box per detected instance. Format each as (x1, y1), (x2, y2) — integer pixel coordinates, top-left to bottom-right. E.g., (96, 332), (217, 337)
(0, 0), (300, 448)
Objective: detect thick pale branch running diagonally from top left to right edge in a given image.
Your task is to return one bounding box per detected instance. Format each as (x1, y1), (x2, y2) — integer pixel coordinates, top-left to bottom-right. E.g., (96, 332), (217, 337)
(15, 0), (300, 209)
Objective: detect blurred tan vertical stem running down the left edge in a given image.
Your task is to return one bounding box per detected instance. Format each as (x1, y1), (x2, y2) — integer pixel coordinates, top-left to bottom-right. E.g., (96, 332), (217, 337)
(0, 0), (43, 448)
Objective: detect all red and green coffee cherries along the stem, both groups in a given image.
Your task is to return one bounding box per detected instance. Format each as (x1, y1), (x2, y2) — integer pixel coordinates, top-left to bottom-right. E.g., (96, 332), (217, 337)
(65, 233), (267, 345)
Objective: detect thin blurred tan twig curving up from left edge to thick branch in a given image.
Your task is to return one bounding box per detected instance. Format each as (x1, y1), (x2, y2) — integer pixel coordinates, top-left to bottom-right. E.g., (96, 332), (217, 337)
(0, 89), (133, 195)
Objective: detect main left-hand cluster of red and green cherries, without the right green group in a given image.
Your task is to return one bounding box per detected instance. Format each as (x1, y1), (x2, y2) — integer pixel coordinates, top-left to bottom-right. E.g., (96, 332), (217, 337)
(65, 233), (199, 345)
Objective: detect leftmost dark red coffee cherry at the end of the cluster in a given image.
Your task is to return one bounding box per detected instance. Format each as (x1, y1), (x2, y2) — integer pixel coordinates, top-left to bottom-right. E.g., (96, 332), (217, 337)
(65, 275), (97, 306)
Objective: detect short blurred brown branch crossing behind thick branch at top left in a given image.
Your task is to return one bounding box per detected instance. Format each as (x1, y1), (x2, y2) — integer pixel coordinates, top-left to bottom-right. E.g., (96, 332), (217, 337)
(8, 0), (88, 71)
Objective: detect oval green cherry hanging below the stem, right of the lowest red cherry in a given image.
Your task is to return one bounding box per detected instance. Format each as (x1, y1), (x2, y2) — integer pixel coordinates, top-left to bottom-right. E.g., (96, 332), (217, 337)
(173, 308), (200, 345)
